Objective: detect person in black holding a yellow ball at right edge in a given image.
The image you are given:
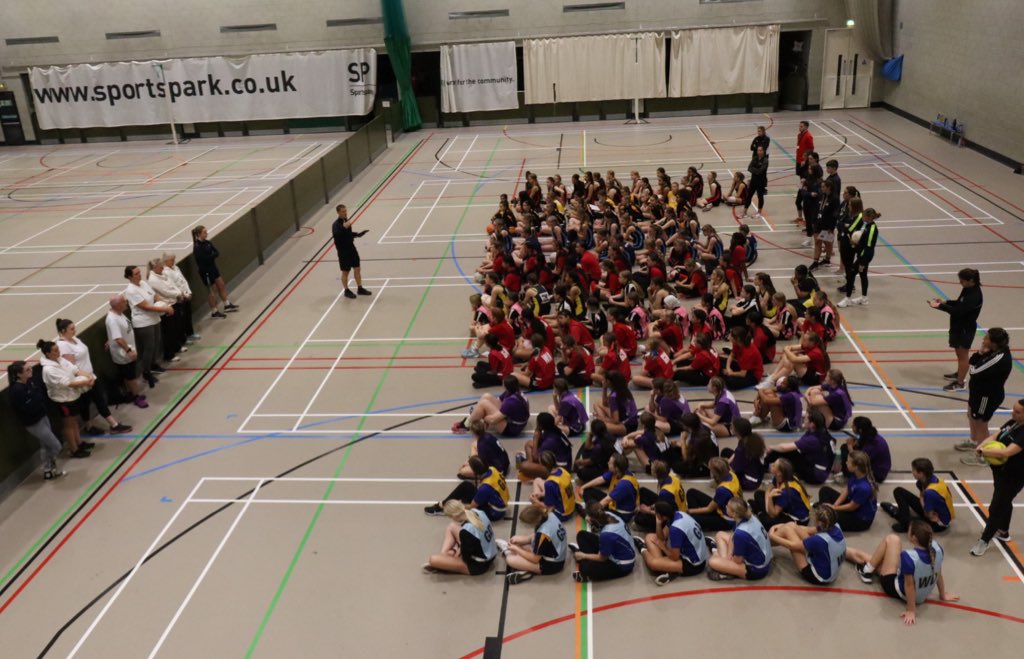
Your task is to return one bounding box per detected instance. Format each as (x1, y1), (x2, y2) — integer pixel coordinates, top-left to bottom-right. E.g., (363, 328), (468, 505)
(971, 399), (1024, 556)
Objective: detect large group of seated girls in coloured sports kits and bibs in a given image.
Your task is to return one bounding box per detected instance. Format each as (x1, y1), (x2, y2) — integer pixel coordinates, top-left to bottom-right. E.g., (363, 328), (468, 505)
(424, 161), (956, 623)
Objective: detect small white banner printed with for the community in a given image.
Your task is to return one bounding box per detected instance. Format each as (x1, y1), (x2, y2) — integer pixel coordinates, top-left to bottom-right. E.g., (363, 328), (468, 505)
(441, 41), (519, 113)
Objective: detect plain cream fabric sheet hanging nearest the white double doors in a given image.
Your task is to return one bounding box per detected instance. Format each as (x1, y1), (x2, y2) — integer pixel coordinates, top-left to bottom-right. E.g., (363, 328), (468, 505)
(669, 26), (779, 97)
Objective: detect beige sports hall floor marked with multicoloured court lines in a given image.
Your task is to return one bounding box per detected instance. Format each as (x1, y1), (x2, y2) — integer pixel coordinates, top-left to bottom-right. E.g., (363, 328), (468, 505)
(0, 111), (1024, 659)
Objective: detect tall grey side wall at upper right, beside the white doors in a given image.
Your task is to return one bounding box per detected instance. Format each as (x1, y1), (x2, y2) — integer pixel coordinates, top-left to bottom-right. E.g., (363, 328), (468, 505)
(883, 0), (1024, 162)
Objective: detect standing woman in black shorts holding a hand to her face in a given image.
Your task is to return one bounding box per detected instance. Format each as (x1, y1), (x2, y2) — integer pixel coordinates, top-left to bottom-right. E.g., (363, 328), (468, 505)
(953, 327), (1014, 467)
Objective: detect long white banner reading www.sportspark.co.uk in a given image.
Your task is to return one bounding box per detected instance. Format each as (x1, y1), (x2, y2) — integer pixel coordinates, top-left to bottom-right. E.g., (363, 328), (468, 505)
(29, 48), (377, 129)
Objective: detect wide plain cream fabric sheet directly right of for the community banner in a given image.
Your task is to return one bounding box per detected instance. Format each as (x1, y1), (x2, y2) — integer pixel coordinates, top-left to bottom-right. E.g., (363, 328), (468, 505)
(522, 32), (666, 103)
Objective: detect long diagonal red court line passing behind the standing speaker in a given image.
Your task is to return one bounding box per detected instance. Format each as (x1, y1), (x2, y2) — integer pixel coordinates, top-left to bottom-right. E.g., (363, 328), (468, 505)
(0, 132), (433, 614)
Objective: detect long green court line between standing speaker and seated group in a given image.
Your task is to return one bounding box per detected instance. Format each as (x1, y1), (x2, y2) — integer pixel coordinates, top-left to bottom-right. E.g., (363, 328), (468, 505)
(245, 138), (502, 659)
